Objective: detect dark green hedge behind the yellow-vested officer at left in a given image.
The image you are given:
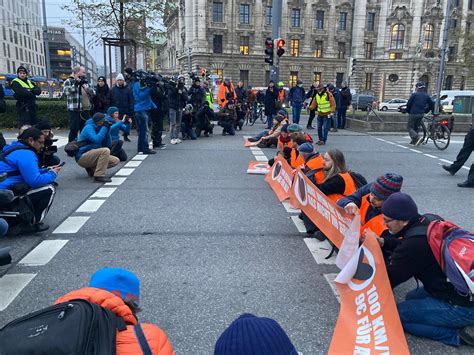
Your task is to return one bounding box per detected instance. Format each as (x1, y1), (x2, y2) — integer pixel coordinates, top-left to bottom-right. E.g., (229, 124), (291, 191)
(0, 98), (69, 128)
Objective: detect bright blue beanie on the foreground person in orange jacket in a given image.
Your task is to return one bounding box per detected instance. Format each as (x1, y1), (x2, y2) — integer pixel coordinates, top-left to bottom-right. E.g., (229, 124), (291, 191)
(89, 267), (140, 305)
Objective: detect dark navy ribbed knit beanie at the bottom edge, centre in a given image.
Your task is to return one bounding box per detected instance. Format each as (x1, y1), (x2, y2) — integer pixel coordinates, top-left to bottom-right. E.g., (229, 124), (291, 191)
(214, 313), (298, 355)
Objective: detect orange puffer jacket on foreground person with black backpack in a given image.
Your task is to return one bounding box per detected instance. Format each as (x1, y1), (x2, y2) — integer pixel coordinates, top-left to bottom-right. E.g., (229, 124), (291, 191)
(54, 287), (174, 355)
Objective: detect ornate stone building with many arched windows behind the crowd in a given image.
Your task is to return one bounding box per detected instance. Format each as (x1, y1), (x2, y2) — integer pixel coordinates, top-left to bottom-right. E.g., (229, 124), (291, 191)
(160, 0), (474, 99)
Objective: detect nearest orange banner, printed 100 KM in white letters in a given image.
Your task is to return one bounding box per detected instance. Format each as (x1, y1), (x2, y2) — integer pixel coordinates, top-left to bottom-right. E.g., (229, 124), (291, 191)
(328, 238), (410, 354)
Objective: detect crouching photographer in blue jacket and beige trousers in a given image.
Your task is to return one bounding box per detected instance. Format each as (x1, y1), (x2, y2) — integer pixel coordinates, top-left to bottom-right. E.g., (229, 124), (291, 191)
(76, 112), (120, 182)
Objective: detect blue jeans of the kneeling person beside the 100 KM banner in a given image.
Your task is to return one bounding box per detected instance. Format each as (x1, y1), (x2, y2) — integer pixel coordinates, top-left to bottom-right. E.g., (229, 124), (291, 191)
(397, 287), (474, 346)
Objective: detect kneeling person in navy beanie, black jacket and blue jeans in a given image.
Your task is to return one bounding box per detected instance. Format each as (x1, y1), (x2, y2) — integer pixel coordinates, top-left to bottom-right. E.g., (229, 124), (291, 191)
(366, 192), (474, 346)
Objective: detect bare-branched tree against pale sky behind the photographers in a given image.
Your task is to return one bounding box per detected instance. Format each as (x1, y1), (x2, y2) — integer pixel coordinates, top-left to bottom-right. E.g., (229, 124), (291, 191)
(62, 0), (166, 70)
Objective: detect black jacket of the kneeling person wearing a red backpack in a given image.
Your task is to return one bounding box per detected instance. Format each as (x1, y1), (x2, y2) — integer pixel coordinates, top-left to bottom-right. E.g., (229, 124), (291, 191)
(387, 216), (474, 307)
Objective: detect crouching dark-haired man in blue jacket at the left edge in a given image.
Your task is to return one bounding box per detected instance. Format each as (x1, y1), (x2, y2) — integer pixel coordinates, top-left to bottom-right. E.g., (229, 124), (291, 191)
(0, 128), (61, 235)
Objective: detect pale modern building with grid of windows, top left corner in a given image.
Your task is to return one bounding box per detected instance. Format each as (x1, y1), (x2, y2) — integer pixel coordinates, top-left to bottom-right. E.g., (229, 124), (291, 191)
(0, 0), (46, 76)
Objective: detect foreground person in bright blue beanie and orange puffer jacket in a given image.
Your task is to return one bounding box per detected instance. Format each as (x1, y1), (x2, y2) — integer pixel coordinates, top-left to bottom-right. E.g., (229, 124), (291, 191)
(54, 268), (173, 355)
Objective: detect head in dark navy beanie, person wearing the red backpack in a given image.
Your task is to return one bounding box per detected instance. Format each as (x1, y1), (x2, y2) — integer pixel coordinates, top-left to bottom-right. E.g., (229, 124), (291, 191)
(382, 192), (419, 234)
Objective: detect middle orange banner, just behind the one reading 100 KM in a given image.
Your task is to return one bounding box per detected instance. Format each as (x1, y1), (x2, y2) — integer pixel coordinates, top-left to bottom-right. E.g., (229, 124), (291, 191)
(290, 168), (351, 248)
